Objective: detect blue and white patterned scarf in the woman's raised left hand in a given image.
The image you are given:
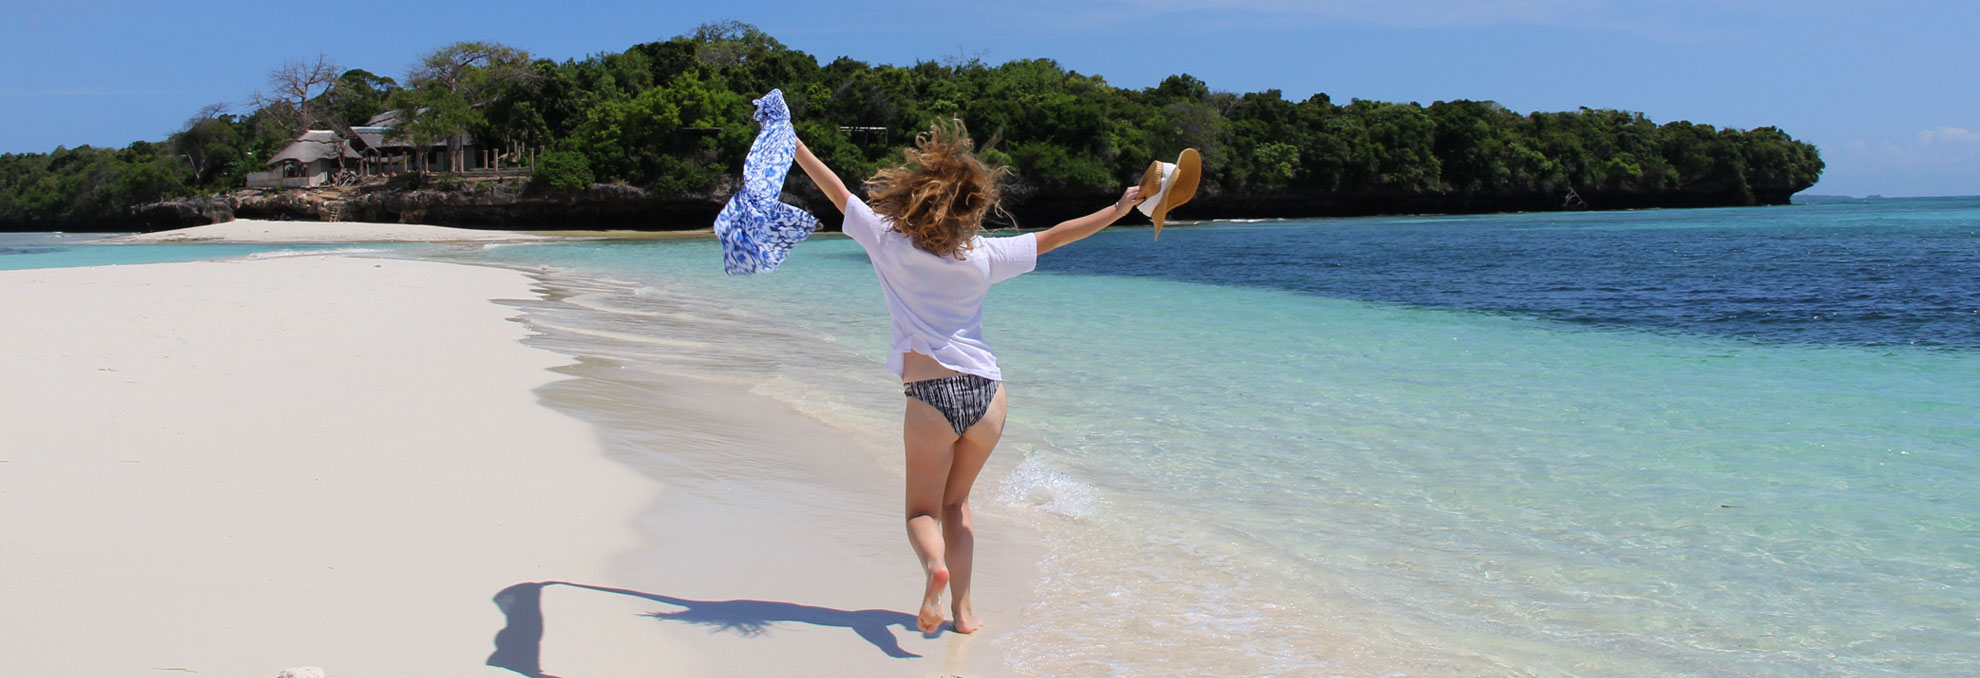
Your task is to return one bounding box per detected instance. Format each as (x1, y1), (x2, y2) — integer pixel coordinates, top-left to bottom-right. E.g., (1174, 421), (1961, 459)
(715, 89), (818, 276)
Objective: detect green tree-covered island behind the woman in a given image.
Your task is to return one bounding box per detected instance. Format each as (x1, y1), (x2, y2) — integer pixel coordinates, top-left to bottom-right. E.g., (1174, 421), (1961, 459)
(0, 22), (1824, 230)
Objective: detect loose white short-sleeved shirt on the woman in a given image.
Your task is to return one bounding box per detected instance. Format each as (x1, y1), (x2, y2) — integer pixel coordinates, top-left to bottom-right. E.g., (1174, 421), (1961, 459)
(845, 196), (1038, 381)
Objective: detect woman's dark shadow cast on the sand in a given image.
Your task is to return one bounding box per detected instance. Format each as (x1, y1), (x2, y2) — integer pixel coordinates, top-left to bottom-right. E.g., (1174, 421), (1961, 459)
(487, 581), (921, 678)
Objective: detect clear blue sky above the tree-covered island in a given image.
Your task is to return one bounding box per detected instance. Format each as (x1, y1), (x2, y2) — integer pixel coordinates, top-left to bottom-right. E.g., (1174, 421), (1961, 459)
(0, 0), (1980, 196)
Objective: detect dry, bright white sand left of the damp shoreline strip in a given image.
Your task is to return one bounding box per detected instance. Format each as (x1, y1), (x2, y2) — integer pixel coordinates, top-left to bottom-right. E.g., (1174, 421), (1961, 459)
(0, 258), (659, 676)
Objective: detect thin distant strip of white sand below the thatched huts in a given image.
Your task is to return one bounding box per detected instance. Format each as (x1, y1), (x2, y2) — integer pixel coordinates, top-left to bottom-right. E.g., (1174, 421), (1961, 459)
(105, 218), (546, 244)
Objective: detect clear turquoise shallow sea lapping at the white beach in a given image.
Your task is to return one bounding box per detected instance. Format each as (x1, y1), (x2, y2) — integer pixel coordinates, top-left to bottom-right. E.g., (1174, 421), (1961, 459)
(425, 202), (1980, 676)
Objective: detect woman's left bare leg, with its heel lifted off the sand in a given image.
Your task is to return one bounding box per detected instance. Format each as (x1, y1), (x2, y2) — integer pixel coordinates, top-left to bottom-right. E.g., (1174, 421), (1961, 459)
(901, 398), (956, 632)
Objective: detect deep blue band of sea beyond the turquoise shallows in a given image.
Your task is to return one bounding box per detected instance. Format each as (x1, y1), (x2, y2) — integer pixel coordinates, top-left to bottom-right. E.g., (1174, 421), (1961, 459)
(1047, 198), (1980, 347)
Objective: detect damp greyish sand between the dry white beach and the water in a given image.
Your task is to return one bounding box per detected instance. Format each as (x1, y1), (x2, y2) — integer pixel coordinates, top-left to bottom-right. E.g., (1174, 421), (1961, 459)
(489, 261), (1041, 676)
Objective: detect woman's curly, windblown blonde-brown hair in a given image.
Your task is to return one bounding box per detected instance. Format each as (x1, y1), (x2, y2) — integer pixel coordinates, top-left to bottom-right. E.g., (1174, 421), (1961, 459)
(865, 119), (1010, 260)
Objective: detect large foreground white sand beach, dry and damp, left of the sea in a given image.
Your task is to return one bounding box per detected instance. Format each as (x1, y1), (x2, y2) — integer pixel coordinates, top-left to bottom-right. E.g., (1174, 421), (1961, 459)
(0, 255), (1036, 678)
